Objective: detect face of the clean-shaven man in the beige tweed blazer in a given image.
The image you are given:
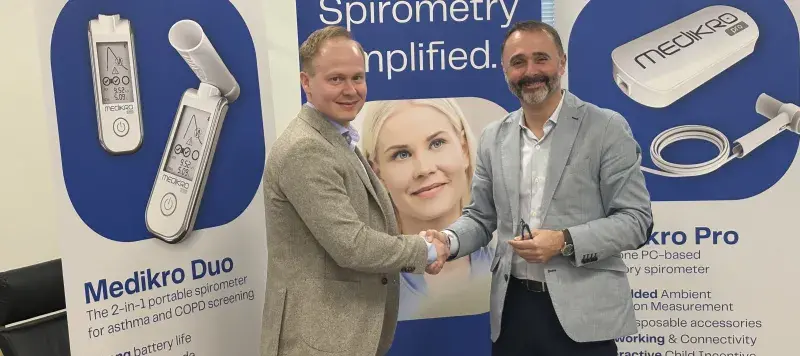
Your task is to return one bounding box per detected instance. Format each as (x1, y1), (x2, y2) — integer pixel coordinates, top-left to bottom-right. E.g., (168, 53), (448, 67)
(300, 38), (367, 126)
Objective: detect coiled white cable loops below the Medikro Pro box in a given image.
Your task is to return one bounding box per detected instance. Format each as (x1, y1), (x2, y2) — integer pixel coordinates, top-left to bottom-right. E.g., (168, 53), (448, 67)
(642, 125), (736, 178)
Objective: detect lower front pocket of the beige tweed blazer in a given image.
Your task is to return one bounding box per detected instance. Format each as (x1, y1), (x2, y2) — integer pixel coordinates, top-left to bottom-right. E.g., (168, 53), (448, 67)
(294, 280), (366, 353)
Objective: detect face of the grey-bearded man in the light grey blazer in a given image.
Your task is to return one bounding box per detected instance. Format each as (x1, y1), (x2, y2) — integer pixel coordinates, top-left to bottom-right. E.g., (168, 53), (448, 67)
(503, 30), (566, 105)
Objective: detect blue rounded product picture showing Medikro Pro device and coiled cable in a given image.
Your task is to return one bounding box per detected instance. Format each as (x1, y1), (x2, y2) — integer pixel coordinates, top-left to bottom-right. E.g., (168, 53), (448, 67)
(568, 0), (800, 201)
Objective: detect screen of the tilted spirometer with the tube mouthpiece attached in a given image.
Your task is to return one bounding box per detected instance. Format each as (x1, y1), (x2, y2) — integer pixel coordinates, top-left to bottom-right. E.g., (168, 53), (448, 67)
(165, 106), (211, 181)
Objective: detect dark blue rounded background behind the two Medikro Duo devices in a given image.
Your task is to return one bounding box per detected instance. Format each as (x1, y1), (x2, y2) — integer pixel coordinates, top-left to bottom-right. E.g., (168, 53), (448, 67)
(51, 0), (265, 242)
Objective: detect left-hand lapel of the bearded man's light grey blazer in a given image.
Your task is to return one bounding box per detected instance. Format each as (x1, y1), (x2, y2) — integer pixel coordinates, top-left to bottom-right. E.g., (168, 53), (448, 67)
(499, 109), (522, 233)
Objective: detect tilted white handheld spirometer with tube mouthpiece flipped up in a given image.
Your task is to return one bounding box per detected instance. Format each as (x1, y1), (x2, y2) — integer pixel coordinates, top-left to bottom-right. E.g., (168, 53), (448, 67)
(145, 20), (239, 243)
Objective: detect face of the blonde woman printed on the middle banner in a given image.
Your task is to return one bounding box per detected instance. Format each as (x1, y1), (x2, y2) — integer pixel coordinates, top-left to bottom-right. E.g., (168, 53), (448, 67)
(374, 105), (469, 222)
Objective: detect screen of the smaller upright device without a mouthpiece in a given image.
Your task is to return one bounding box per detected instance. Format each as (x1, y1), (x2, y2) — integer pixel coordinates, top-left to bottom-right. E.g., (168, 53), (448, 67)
(95, 42), (133, 104)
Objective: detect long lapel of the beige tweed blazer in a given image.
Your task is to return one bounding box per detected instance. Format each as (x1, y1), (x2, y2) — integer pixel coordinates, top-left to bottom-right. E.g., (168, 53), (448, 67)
(298, 105), (391, 221)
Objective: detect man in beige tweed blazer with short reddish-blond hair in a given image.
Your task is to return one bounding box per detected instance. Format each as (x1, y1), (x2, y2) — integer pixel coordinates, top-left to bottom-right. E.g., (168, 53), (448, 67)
(261, 26), (449, 356)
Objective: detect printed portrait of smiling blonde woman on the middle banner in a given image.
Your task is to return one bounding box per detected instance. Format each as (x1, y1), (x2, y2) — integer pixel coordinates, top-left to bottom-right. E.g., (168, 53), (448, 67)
(355, 98), (508, 320)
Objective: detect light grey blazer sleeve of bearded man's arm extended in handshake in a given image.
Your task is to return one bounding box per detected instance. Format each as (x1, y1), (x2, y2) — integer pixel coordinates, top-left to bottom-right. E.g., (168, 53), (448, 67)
(446, 130), (497, 258)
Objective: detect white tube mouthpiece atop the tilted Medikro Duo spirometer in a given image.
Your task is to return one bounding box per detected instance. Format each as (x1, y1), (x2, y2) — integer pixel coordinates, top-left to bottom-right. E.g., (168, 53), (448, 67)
(169, 20), (239, 102)
